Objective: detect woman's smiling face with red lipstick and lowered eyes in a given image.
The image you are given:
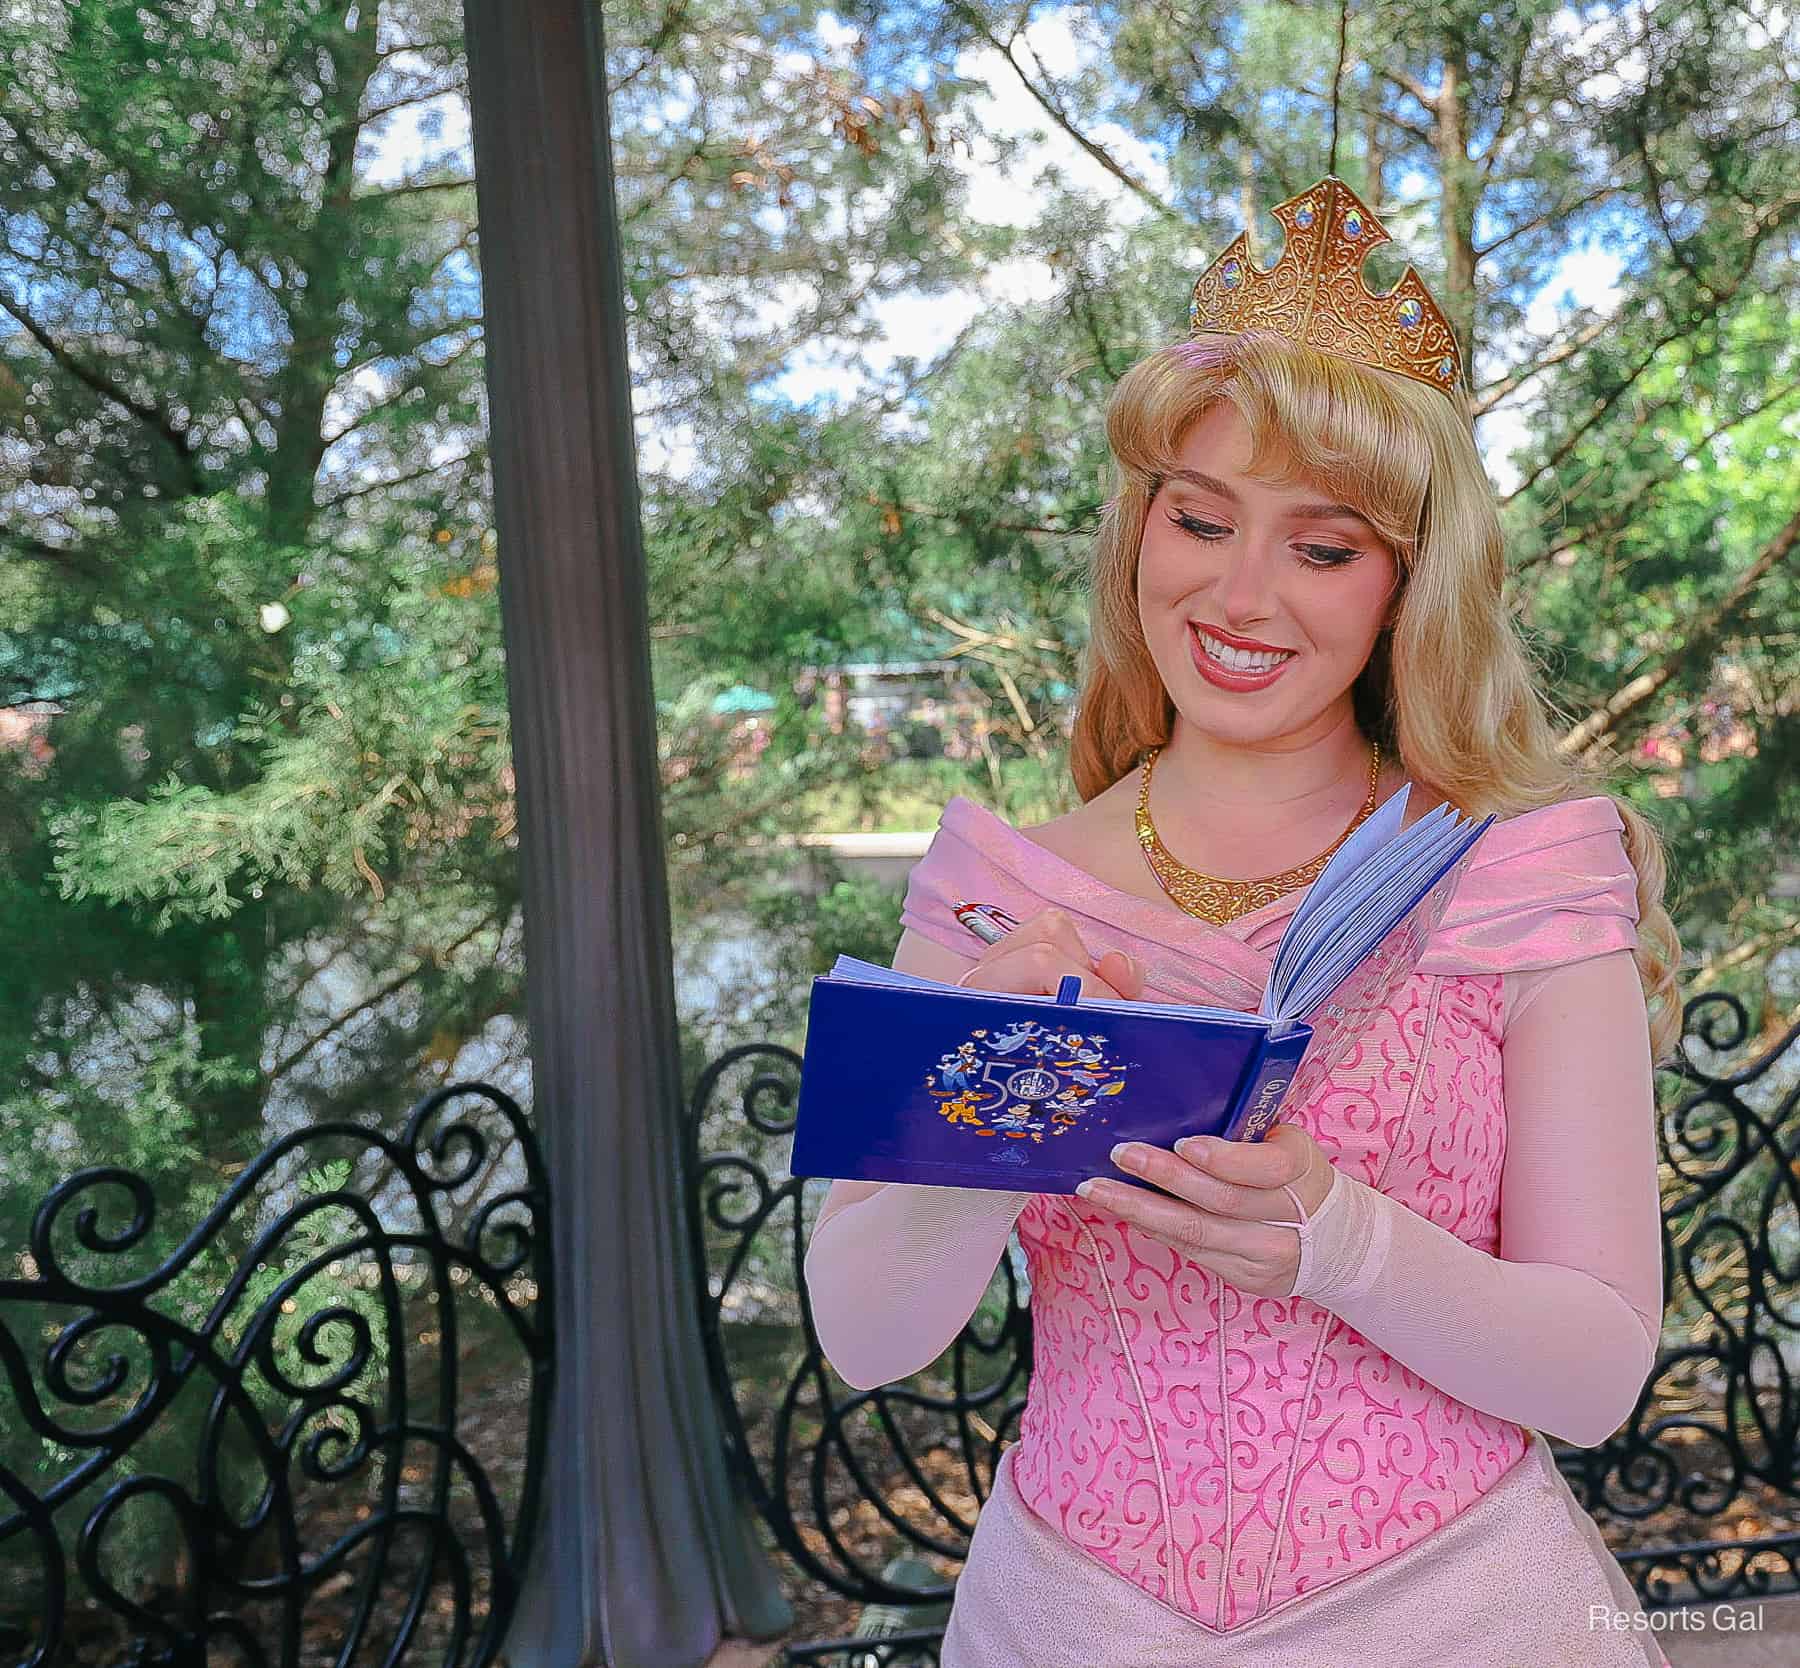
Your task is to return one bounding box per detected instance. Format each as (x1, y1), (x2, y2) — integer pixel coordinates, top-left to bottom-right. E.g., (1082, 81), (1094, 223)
(1138, 399), (1400, 745)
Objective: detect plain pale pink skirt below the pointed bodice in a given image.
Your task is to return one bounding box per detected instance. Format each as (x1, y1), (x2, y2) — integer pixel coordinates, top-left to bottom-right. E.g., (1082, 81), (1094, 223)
(941, 1432), (1669, 1668)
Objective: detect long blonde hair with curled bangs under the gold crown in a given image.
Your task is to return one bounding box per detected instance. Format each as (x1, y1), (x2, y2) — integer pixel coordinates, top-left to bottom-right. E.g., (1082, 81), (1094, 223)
(1069, 331), (1681, 1063)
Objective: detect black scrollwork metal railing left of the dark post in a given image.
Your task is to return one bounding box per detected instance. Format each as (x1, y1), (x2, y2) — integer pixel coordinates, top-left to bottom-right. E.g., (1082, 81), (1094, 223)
(0, 1083), (551, 1668)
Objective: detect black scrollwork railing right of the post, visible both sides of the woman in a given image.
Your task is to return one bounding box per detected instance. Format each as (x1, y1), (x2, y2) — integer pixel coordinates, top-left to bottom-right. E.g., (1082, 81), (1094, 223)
(684, 993), (1800, 1668)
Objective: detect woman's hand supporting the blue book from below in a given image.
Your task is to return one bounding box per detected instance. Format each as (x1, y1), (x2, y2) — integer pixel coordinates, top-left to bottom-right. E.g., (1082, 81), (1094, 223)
(1078, 1123), (1332, 1297)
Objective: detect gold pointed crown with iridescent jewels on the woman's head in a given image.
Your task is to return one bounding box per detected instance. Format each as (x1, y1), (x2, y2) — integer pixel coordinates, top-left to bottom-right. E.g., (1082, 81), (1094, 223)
(1188, 175), (1462, 399)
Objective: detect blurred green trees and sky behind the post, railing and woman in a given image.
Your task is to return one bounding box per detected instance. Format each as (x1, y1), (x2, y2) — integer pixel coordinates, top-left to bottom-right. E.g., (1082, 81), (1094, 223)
(0, 0), (1800, 1662)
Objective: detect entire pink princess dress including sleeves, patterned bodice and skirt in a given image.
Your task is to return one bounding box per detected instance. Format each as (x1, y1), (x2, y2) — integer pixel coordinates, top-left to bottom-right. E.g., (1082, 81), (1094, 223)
(806, 797), (1667, 1668)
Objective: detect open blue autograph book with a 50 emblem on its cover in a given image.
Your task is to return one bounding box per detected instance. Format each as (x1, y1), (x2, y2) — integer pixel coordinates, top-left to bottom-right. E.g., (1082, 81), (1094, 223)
(788, 786), (1494, 1193)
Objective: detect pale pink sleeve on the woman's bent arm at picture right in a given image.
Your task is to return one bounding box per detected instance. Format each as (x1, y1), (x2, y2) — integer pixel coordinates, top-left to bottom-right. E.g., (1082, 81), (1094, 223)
(1296, 831), (1663, 1447)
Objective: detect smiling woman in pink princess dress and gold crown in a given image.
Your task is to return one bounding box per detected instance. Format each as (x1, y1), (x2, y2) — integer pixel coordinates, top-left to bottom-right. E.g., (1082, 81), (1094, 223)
(806, 178), (1679, 1668)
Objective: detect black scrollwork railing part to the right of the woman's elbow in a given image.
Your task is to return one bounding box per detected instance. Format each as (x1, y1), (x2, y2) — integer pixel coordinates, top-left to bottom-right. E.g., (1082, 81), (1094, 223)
(1584, 991), (1800, 1609)
